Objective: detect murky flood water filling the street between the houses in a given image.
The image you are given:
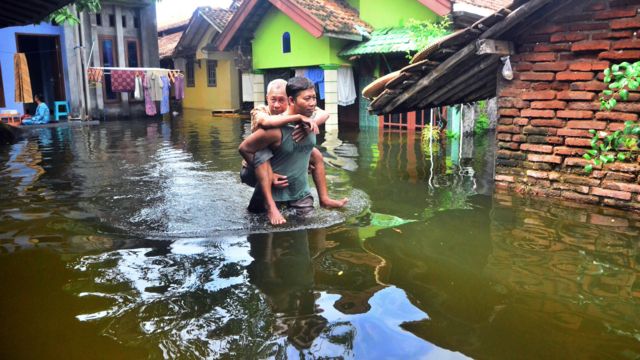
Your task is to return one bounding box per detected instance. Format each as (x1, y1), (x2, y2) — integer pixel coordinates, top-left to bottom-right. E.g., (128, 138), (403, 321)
(0, 112), (640, 359)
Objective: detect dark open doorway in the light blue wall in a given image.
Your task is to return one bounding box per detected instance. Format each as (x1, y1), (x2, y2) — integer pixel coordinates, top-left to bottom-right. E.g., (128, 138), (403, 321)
(16, 34), (66, 114)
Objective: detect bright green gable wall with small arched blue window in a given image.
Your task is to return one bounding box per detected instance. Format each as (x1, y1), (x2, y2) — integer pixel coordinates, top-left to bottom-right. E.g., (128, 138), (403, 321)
(252, 8), (348, 70)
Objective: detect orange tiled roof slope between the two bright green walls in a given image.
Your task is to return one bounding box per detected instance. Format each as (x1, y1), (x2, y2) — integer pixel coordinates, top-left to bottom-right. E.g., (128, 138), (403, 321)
(290, 0), (372, 35)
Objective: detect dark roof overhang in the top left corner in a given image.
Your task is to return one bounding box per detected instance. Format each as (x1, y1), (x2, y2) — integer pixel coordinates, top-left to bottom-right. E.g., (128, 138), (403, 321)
(0, 0), (73, 28)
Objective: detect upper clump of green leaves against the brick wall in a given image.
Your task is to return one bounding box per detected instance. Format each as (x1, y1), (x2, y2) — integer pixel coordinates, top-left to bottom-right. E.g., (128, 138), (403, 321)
(600, 61), (640, 111)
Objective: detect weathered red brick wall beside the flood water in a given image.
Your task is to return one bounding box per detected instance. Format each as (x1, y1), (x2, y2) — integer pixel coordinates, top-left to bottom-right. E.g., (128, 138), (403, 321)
(495, 0), (640, 210)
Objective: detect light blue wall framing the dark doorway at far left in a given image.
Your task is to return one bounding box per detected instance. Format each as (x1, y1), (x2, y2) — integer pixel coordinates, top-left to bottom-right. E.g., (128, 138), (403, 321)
(0, 23), (70, 113)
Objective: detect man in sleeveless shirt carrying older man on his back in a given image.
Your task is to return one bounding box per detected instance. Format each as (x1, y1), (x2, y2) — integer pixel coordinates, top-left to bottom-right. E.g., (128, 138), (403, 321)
(239, 77), (348, 225)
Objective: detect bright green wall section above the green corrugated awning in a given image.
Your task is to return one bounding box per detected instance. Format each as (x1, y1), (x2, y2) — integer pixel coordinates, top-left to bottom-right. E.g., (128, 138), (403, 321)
(358, 0), (438, 29)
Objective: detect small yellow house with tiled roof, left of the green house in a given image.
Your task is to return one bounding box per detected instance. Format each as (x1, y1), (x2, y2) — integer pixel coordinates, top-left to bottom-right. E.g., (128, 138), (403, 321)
(172, 6), (241, 112)
